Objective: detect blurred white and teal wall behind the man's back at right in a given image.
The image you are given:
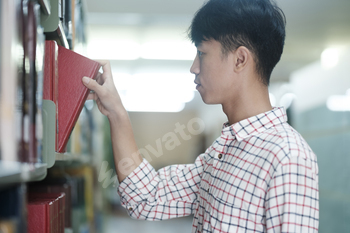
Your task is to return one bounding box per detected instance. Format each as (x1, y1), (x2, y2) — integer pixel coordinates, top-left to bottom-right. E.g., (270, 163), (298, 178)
(291, 46), (350, 233)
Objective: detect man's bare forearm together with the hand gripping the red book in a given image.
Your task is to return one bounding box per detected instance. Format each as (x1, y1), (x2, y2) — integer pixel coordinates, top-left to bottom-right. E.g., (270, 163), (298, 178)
(82, 61), (142, 182)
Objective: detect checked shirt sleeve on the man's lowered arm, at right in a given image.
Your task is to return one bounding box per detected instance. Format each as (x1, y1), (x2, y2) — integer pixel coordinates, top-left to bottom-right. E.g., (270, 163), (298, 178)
(265, 156), (319, 233)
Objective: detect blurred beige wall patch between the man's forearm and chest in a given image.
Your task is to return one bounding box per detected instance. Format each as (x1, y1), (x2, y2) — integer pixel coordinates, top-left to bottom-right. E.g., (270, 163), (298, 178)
(129, 110), (204, 170)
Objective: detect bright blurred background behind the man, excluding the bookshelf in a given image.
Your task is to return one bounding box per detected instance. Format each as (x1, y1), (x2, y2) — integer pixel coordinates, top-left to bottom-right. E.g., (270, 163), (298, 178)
(81, 0), (350, 233)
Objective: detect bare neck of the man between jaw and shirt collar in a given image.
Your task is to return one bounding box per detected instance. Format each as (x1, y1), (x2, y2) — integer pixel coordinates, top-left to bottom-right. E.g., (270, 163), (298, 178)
(222, 84), (272, 125)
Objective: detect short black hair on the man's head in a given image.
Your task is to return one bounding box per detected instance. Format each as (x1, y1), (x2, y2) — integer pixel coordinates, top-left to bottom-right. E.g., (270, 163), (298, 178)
(189, 0), (286, 85)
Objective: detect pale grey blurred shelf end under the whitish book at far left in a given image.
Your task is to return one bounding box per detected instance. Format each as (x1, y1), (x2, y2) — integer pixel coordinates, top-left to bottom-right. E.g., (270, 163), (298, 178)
(0, 160), (47, 187)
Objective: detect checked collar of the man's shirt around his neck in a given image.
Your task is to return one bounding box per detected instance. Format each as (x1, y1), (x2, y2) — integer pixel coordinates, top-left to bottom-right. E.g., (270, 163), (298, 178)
(221, 107), (287, 142)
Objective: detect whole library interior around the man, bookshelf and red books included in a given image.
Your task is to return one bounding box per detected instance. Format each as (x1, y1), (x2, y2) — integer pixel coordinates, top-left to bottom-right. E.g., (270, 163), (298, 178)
(0, 0), (350, 233)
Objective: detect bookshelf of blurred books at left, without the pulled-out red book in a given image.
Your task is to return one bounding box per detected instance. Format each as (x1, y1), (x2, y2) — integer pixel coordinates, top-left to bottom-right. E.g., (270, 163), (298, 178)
(0, 0), (103, 233)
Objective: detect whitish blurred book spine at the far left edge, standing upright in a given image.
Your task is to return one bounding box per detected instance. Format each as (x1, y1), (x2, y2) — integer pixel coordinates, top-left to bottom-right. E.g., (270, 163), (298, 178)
(0, 0), (25, 161)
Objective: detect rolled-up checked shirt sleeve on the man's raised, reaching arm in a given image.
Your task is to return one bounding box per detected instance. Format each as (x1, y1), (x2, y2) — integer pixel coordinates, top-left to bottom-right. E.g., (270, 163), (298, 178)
(118, 154), (205, 221)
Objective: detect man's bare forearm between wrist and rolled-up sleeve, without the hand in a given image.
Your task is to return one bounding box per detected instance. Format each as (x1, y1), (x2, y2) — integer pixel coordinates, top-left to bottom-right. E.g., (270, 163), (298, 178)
(108, 110), (142, 182)
